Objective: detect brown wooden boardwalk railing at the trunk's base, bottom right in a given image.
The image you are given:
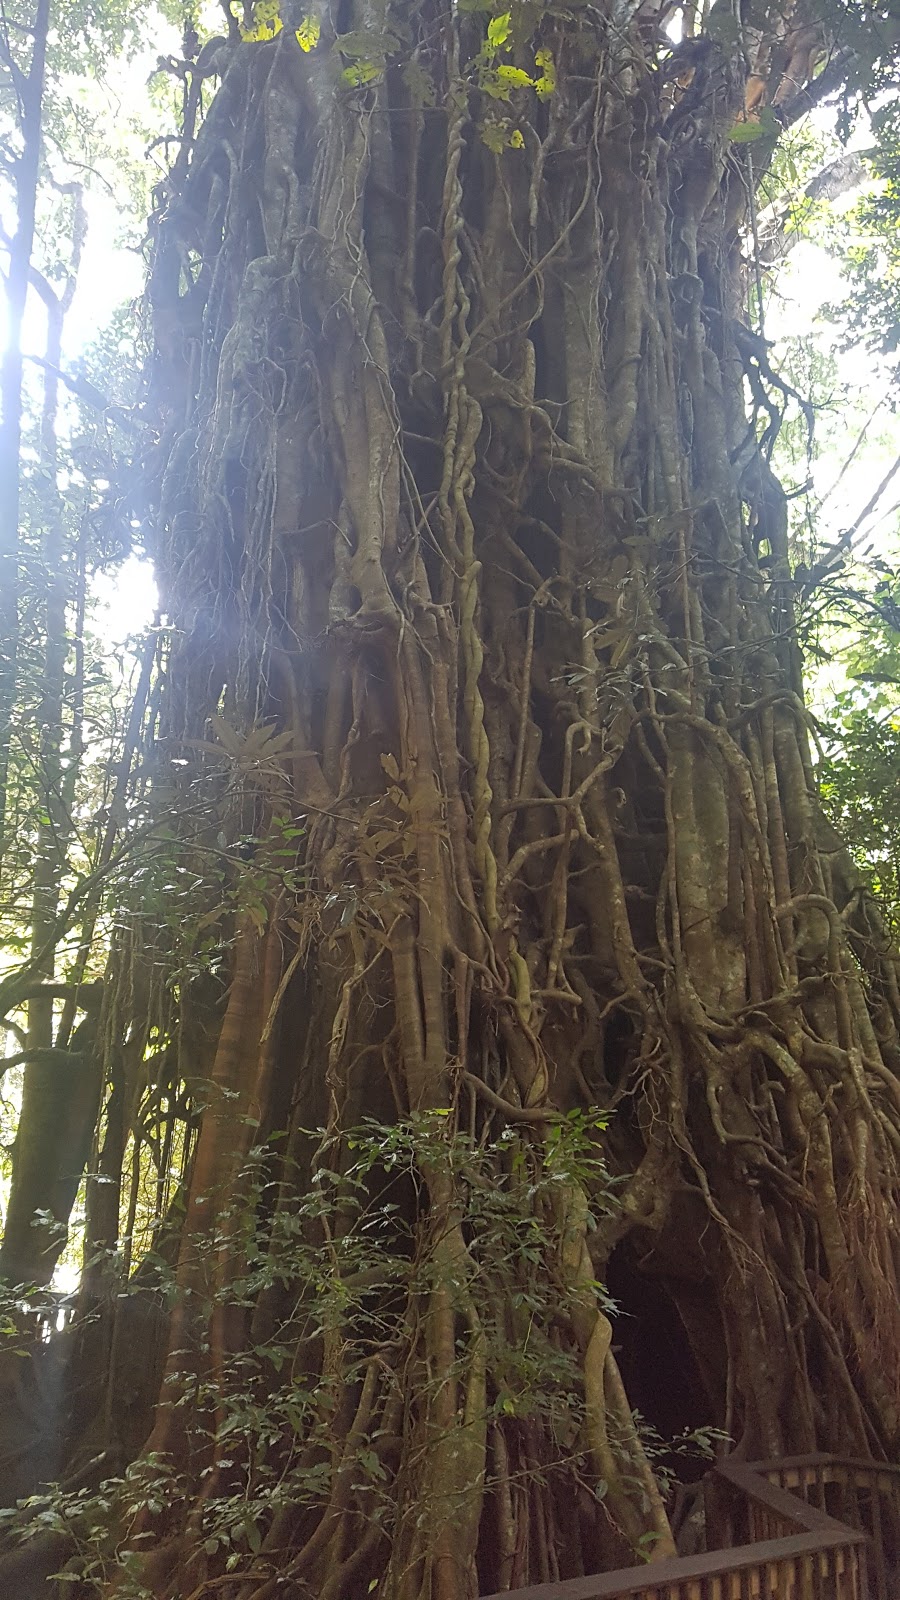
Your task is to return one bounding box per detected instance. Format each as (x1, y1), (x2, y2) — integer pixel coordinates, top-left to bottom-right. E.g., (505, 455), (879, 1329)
(484, 1456), (900, 1600)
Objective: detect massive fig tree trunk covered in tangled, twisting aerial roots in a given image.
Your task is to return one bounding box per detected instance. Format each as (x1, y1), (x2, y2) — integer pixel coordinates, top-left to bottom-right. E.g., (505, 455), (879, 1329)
(1, 0), (900, 1600)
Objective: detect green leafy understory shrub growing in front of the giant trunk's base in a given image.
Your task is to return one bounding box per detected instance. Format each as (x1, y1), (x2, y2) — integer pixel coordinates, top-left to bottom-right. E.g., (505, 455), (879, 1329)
(0, 1109), (650, 1600)
